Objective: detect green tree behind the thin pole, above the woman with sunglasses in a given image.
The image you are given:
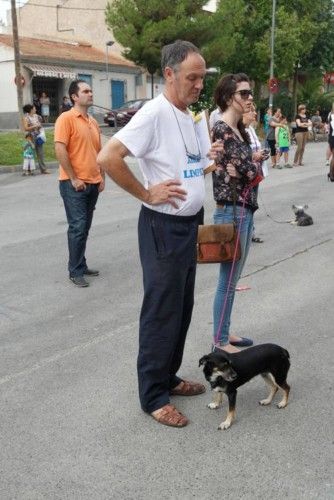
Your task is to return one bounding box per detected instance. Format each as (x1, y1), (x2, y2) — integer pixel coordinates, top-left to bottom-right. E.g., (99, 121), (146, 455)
(205, 0), (334, 105)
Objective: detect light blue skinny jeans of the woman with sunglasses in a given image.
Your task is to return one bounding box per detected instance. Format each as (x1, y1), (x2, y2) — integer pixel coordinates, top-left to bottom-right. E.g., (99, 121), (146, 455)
(213, 205), (253, 345)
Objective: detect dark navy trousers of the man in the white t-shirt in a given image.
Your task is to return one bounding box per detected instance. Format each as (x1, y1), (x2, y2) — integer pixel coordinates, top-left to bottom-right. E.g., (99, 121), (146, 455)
(137, 206), (199, 413)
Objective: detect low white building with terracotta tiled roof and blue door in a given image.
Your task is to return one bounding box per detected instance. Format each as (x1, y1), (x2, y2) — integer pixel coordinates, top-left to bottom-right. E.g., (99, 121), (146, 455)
(0, 35), (143, 128)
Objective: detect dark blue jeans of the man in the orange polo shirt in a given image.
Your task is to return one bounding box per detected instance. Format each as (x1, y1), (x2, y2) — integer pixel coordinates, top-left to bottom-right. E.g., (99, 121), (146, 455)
(59, 180), (99, 278)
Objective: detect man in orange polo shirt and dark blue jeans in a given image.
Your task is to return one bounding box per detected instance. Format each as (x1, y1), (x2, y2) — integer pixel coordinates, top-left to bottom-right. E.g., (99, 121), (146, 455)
(54, 80), (104, 287)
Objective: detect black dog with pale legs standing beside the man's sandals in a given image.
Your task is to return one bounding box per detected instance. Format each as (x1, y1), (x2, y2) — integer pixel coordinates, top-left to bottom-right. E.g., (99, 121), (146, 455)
(199, 344), (290, 429)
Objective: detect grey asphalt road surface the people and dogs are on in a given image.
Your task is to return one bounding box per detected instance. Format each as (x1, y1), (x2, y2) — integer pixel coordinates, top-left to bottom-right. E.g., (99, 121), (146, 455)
(0, 143), (334, 500)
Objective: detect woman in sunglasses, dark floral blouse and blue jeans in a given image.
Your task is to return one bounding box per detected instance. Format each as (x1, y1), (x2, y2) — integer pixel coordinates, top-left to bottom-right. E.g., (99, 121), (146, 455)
(212, 73), (268, 352)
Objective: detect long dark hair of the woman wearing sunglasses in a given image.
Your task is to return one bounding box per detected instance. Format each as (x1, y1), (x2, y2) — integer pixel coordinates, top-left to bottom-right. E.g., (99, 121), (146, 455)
(214, 73), (250, 144)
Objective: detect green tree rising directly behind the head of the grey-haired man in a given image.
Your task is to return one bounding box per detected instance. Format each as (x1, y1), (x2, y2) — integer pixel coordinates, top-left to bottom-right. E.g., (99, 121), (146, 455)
(106, 0), (213, 96)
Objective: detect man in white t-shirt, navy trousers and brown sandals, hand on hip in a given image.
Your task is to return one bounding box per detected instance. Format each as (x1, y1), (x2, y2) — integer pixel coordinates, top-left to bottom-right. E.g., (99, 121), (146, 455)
(98, 40), (210, 427)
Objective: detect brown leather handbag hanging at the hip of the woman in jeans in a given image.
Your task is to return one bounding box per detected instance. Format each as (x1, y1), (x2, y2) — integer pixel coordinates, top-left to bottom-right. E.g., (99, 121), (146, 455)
(197, 186), (241, 264)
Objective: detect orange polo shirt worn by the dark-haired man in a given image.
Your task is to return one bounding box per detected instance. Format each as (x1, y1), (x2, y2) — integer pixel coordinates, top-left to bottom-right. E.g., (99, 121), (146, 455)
(54, 108), (102, 184)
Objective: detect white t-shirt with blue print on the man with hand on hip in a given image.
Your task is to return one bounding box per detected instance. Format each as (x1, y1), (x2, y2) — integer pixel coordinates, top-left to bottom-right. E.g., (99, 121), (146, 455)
(114, 94), (212, 216)
